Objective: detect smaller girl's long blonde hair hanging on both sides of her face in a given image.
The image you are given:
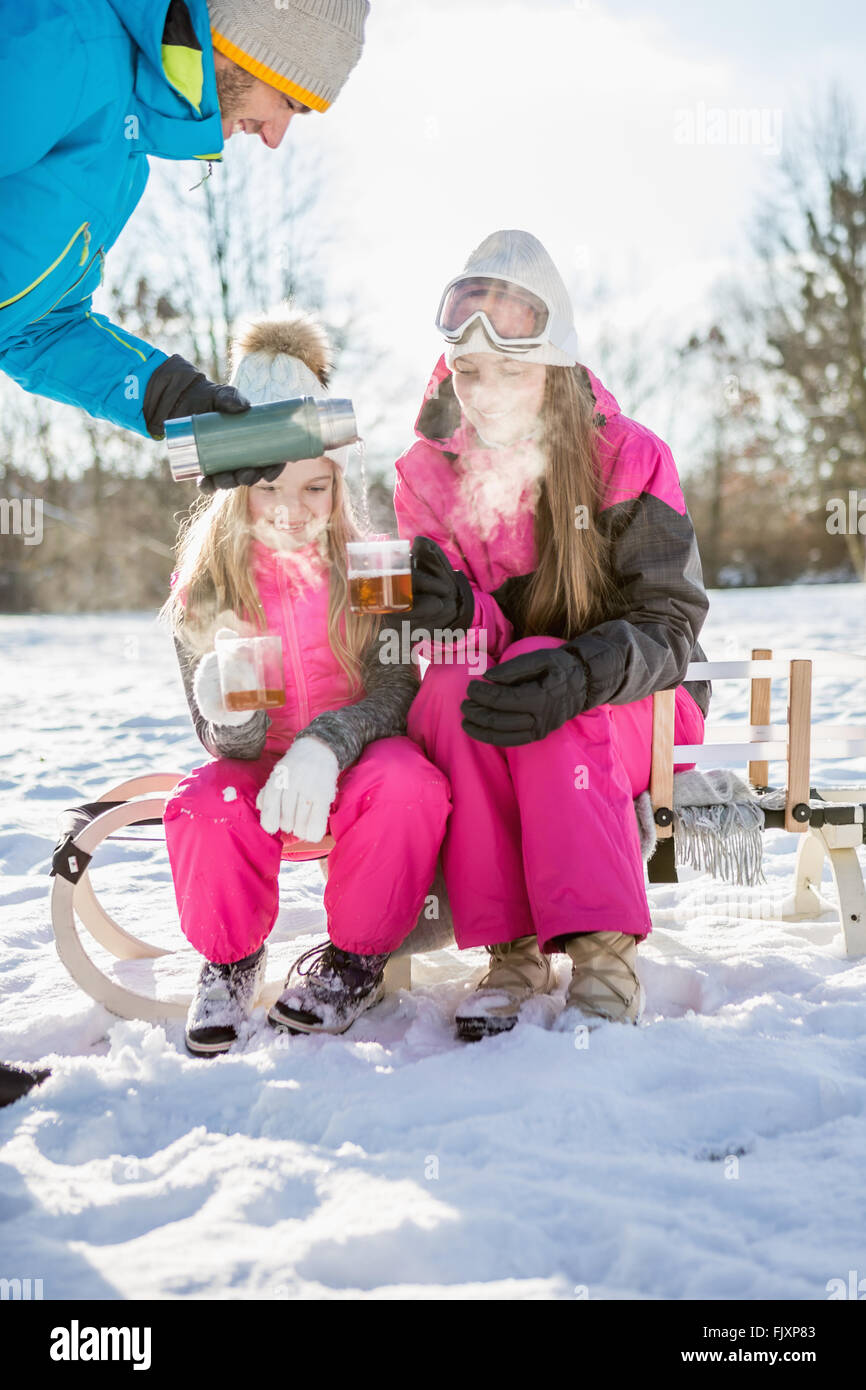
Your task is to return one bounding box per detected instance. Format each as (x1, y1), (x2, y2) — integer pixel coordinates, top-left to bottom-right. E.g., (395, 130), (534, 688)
(158, 464), (381, 691)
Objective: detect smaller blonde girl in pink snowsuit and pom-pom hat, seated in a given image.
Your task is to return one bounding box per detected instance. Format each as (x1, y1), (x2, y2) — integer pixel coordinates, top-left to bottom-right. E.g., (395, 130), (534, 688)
(163, 311), (450, 1055)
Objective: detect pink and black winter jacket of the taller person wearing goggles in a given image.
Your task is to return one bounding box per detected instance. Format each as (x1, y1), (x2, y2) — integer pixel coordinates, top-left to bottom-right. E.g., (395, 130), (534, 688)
(393, 356), (712, 716)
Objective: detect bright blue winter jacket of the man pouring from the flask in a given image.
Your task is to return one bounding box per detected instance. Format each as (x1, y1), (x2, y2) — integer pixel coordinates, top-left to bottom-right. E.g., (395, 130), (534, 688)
(0, 0), (224, 438)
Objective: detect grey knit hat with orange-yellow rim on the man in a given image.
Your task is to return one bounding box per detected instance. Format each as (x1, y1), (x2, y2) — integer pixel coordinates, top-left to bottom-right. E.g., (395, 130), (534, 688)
(207, 0), (370, 111)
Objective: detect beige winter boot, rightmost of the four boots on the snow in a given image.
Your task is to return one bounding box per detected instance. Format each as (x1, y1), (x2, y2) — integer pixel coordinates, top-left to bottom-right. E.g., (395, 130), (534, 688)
(563, 931), (644, 1023)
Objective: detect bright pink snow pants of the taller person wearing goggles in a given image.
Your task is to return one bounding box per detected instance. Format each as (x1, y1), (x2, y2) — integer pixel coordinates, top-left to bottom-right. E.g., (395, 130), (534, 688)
(407, 637), (703, 951)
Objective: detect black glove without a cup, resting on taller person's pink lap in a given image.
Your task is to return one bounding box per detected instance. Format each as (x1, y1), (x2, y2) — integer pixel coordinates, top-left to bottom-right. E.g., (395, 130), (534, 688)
(460, 646), (588, 748)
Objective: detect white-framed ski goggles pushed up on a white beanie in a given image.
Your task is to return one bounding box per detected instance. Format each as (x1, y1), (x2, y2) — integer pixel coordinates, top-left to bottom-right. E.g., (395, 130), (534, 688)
(436, 275), (577, 354)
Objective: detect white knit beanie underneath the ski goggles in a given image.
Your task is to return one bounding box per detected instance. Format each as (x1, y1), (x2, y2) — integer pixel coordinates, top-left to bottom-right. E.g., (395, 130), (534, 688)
(445, 231), (577, 367)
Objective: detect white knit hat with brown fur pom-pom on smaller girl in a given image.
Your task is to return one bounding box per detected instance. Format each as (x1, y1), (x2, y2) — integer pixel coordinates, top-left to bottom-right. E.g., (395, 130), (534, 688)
(229, 304), (350, 473)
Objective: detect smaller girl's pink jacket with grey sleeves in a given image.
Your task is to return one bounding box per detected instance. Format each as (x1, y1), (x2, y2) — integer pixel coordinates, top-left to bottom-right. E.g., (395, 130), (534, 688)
(175, 539), (418, 771)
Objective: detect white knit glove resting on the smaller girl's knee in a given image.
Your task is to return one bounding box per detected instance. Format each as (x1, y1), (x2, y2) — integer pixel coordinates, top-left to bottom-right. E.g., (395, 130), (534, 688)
(256, 735), (339, 842)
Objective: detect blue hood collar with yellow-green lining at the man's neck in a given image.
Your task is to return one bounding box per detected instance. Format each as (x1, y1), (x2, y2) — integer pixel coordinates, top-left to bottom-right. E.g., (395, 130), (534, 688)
(107, 0), (225, 160)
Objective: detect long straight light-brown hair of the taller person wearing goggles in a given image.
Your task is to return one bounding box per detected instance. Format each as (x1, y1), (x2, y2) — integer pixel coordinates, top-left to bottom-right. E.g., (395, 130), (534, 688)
(523, 363), (617, 638)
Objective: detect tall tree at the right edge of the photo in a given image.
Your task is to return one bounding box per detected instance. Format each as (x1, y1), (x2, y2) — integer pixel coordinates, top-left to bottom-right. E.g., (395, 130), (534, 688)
(751, 88), (866, 578)
